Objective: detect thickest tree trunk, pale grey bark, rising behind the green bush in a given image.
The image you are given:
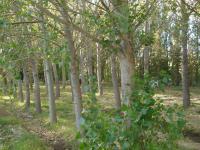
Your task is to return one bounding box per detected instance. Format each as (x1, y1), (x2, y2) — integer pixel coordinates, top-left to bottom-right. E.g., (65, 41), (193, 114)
(111, 0), (135, 105)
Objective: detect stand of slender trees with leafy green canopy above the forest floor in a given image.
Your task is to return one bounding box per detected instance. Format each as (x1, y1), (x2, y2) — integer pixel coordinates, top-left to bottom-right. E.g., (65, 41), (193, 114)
(0, 0), (200, 129)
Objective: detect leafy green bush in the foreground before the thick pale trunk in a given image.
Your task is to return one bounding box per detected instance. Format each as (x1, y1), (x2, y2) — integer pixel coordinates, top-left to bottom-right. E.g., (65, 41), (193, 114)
(77, 77), (185, 150)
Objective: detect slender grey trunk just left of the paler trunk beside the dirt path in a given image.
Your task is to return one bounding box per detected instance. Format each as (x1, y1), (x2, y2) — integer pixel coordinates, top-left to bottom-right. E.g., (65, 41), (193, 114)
(31, 59), (42, 113)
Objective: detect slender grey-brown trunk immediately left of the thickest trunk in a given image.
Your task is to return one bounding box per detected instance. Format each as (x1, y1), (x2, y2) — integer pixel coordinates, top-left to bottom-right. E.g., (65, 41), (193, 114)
(111, 54), (121, 109)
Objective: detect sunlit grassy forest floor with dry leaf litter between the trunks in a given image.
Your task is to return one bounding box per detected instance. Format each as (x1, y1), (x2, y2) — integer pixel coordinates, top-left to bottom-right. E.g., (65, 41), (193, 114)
(0, 86), (200, 150)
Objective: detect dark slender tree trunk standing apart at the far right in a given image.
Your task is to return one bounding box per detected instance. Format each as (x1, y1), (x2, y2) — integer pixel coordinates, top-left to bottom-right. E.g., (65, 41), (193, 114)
(181, 2), (190, 108)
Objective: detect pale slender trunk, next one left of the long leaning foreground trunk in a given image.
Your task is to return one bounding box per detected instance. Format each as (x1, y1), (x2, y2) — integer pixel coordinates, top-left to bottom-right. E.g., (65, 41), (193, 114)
(45, 60), (57, 123)
